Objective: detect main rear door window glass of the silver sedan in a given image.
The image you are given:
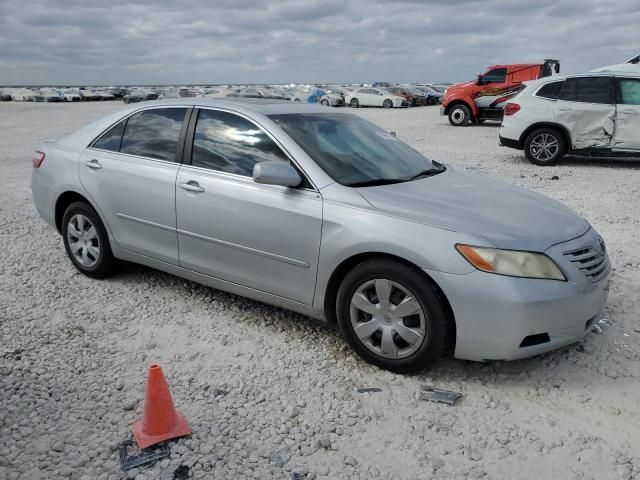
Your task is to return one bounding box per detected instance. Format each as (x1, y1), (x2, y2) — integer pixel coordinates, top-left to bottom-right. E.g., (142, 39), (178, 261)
(120, 108), (187, 162)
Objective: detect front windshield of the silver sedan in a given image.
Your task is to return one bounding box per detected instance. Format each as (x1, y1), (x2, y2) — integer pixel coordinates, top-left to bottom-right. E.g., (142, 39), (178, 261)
(269, 113), (444, 187)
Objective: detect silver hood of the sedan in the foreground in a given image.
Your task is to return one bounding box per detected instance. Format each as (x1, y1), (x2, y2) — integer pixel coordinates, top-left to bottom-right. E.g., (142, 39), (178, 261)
(358, 169), (590, 252)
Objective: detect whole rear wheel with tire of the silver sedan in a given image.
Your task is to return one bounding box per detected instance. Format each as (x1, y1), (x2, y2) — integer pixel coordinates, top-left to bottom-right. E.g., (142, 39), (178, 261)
(62, 202), (116, 278)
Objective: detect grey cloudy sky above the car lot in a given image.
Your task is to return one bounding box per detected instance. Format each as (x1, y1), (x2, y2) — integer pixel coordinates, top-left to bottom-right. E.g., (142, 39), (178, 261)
(0, 0), (640, 85)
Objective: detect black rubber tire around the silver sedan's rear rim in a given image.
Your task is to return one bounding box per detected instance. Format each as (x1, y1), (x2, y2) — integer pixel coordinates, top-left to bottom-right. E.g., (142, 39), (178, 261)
(62, 202), (116, 278)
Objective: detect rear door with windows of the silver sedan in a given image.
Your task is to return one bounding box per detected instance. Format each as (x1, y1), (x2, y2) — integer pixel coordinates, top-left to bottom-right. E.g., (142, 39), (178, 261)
(79, 107), (189, 265)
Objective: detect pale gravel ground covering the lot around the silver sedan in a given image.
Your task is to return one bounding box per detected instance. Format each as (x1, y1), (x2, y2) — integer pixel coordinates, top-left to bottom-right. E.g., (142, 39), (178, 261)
(0, 103), (640, 480)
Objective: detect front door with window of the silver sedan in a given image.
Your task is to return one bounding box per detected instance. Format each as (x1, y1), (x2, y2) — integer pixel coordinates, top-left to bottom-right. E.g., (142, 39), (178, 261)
(176, 109), (322, 305)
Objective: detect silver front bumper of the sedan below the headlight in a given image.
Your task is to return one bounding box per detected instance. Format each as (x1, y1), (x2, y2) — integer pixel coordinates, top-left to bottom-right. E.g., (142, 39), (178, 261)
(426, 229), (610, 361)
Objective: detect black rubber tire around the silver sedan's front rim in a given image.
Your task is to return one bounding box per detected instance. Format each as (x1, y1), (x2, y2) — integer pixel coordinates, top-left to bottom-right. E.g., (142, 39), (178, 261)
(336, 258), (453, 372)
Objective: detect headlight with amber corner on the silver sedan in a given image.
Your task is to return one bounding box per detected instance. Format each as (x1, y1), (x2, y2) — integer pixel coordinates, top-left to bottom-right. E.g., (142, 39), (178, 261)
(456, 244), (566, 281)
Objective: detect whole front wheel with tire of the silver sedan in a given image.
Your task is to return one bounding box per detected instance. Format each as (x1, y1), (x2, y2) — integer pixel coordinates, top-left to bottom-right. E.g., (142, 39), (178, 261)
(336, 259), (448, 372)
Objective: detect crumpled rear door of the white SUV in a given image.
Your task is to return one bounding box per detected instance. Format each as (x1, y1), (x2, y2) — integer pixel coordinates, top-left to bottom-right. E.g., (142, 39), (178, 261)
(556, 76), (616, 149)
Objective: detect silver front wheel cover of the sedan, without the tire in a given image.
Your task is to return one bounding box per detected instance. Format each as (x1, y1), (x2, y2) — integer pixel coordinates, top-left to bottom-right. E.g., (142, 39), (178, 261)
(350, 278), (427, 359)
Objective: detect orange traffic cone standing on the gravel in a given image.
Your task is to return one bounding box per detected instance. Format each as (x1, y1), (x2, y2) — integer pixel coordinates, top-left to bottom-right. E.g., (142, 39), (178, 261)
(131, 365), (191, 449)
